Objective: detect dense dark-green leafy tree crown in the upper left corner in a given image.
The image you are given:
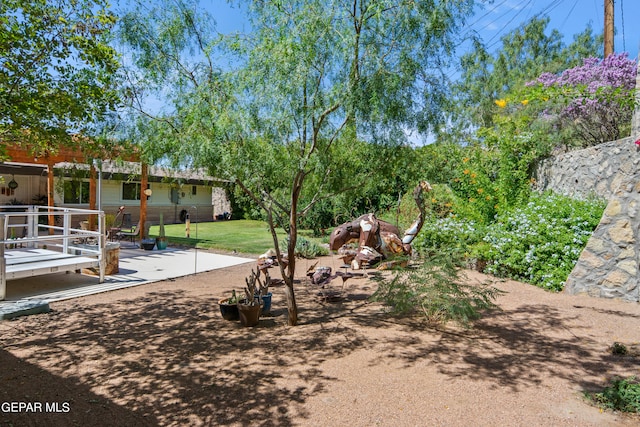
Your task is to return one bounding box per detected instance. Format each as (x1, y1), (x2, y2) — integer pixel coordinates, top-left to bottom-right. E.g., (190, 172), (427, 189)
(0, 0), (119, 155)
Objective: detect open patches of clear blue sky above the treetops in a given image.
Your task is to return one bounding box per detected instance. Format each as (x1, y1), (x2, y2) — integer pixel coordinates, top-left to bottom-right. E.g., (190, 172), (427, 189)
(201, 0), (640, 59)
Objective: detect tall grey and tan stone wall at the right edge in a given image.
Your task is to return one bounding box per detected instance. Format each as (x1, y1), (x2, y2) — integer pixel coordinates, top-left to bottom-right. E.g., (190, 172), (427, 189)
(536, 138), (640, 301)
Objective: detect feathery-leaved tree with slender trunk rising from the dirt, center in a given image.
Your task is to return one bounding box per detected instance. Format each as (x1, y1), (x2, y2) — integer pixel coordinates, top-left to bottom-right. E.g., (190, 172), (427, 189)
(123, 0), (474, 325)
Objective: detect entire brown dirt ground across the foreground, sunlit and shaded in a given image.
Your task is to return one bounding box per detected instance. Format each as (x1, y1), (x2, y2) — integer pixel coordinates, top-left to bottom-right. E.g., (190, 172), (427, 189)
(0, 257), (640, 426)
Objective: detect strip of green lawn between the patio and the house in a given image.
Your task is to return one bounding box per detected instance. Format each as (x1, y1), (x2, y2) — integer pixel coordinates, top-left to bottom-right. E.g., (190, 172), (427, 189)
(149, 219), (286, 254)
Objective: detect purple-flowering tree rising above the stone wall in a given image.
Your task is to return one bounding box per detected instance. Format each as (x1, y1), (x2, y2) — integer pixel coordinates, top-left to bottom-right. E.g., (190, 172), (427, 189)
(523, 53), (636, 146)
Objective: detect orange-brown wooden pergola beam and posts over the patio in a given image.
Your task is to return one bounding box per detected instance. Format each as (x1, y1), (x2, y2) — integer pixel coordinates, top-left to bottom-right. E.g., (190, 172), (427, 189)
(6, 144), (148, 238)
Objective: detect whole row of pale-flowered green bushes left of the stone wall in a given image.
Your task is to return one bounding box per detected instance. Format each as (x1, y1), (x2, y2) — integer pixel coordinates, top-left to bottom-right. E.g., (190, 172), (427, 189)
(413, 193), (605, 291)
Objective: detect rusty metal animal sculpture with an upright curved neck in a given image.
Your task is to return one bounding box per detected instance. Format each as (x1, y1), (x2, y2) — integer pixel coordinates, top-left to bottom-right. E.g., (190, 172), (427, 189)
(329, 181), (431, 269)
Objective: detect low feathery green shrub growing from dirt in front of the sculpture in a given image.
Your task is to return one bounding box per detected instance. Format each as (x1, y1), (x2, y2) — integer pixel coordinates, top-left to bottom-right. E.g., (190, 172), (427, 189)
(372, 250), (501, 327)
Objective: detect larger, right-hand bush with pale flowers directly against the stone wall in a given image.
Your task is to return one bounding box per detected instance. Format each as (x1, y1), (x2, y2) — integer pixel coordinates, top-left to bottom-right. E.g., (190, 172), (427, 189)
(483, 193), (605, 291)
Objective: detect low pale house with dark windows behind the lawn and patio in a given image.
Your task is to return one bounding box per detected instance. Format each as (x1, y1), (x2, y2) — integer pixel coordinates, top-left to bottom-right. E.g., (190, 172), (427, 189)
(0, 161), (231, 225)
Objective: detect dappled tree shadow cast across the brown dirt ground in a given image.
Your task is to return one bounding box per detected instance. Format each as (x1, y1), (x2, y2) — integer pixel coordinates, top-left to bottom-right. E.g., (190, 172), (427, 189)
(0, 272), (635, 426)
